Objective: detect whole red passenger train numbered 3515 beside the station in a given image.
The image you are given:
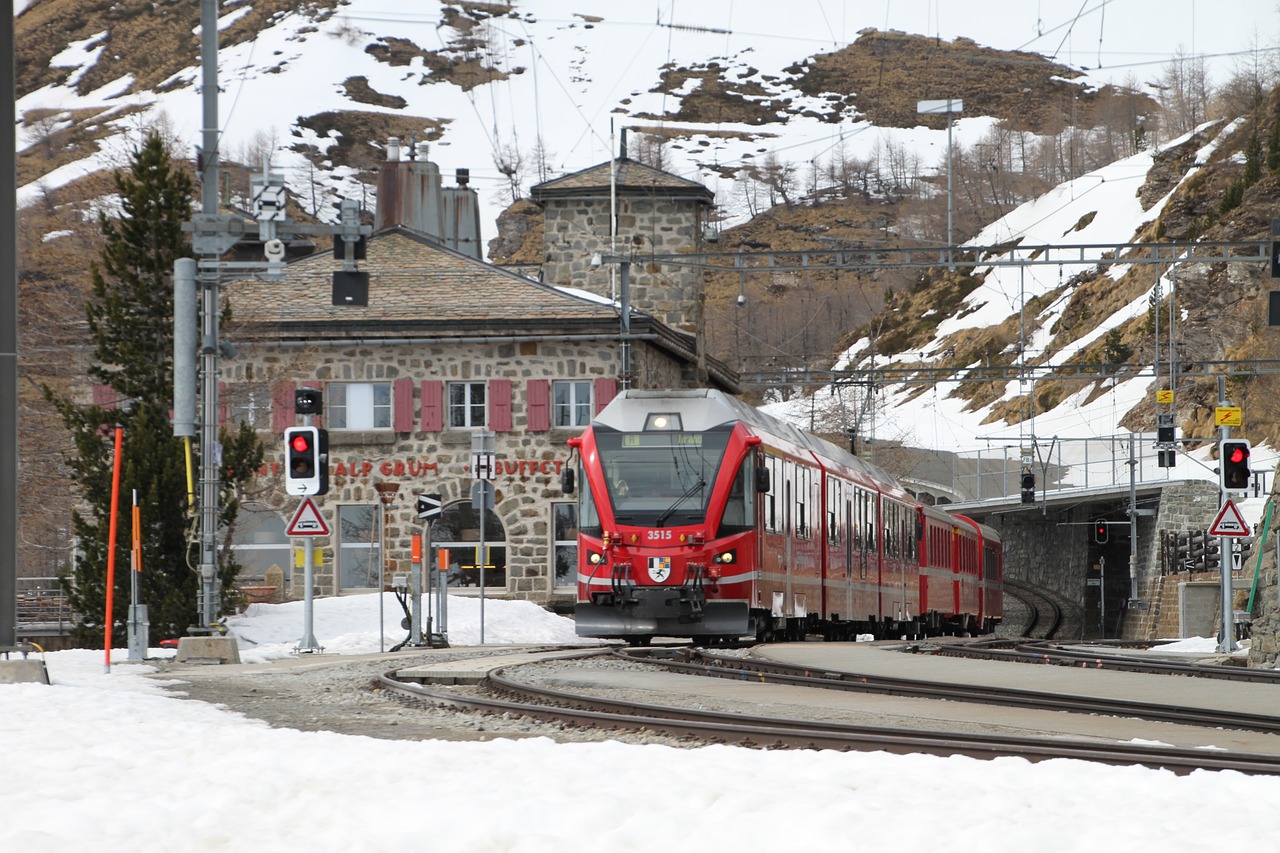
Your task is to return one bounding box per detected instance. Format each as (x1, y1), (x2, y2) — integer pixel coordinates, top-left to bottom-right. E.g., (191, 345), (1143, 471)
(564, 389), (1004, 644)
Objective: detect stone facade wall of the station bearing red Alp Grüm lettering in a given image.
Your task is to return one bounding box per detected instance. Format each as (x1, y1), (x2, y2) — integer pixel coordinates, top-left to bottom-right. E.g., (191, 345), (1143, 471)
(221, 342), (645, 603)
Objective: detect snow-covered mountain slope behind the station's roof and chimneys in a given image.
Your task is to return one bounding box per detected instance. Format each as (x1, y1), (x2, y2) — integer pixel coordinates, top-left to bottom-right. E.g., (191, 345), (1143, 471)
(15, 0), (1277, 238)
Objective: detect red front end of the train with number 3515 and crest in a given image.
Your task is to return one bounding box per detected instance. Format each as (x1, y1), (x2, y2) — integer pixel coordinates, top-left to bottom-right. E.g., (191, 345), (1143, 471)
(570, 396), (758, 643)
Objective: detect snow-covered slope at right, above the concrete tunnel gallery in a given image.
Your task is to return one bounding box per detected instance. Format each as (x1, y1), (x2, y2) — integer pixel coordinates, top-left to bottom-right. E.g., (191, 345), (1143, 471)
(768, 116), (1276, 487)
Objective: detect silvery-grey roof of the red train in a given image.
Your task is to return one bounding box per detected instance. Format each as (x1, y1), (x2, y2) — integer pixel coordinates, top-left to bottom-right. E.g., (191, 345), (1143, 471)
(594, 388), (902, 491)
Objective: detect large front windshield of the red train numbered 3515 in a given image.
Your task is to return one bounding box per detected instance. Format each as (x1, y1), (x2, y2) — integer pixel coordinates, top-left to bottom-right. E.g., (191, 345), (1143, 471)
(595, 428), (730, 528)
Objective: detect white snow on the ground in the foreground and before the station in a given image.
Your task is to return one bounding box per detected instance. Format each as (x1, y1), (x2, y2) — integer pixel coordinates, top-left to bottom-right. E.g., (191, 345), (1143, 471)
(0, 596), (1280, 853)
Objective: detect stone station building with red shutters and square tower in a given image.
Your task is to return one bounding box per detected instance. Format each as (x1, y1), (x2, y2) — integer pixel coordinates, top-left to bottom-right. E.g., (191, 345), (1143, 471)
(221, 146), (737, 606)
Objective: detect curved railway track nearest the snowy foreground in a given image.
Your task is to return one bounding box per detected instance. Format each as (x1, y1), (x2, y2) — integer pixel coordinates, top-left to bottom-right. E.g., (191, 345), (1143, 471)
(378, 649), (1280, 775)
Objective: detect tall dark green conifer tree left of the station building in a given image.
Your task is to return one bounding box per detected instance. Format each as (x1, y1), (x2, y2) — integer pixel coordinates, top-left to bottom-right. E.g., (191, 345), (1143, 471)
(45, 132), (262, 637)
